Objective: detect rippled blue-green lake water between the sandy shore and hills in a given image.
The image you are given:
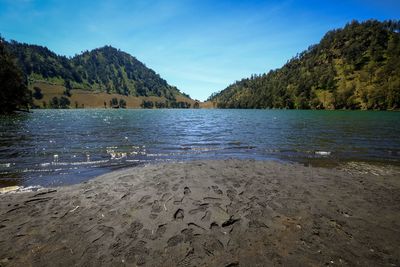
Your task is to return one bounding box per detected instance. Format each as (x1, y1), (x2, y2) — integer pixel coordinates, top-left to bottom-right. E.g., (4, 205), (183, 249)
(0, 110), (400, 186)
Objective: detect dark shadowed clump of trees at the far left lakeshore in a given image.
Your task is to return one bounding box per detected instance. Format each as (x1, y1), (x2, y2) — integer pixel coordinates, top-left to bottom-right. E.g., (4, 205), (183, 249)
(0, 37), (32, 114)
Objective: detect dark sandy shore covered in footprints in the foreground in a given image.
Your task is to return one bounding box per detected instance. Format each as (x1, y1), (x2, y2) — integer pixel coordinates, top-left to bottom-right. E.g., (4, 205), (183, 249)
(0, 160), (400, 266)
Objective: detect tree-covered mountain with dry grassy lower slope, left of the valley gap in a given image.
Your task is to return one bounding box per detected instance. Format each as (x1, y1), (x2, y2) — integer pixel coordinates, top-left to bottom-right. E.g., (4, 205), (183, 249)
(6, 41), (194, 107)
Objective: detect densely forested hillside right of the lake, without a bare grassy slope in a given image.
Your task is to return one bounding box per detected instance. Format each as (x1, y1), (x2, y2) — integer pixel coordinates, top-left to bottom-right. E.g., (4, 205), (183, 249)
(208, 20), (400, 110)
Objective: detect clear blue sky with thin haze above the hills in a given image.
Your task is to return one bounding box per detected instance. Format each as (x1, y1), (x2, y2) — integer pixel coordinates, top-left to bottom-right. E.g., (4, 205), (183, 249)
(0, 0), (400, 101)
